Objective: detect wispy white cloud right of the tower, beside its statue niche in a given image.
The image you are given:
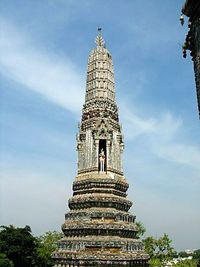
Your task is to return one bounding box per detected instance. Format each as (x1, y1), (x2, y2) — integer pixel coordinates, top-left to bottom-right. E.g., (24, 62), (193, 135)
(122, 105), (200, 172)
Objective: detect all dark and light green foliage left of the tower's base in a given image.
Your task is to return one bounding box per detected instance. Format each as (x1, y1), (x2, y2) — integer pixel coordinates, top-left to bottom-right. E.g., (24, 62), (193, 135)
(0, 225), (63, 267)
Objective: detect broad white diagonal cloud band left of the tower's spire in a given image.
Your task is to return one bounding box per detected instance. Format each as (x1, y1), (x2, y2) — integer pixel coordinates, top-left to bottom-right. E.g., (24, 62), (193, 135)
(0, 17), (85, 112)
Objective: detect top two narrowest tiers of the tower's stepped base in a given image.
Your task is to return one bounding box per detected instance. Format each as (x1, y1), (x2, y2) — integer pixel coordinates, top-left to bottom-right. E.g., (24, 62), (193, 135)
(69, 173), (132, 214)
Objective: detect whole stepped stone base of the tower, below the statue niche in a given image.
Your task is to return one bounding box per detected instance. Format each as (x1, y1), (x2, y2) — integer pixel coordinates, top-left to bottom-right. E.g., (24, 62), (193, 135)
(53, 173), (149, 267)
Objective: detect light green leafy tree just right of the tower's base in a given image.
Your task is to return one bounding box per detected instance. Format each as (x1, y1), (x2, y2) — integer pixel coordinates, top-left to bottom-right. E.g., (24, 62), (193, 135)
(144, 234), (174, 267)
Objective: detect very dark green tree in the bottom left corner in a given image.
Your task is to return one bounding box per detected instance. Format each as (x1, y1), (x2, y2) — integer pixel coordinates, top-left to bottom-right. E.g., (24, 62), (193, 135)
(0, 225), (36, 267)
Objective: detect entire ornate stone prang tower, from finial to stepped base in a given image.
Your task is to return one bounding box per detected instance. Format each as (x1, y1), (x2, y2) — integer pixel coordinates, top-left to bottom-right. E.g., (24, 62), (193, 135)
(53, 31), (148, 267)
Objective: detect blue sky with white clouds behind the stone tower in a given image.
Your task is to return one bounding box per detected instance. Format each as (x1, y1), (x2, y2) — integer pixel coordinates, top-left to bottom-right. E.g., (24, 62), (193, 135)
(0, 0), (200, 250)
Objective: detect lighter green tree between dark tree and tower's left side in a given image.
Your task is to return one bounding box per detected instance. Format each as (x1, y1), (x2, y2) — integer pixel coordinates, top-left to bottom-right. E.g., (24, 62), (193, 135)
(37, 231), (63, 267)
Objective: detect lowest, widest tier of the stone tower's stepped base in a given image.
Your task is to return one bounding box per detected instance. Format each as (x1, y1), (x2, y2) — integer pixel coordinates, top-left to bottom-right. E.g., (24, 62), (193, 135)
(54, 242), (148, 267)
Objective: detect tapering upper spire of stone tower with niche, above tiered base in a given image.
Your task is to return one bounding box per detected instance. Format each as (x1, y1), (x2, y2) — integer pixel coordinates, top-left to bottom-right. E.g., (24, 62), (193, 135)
(77, 29), (124, 177)
